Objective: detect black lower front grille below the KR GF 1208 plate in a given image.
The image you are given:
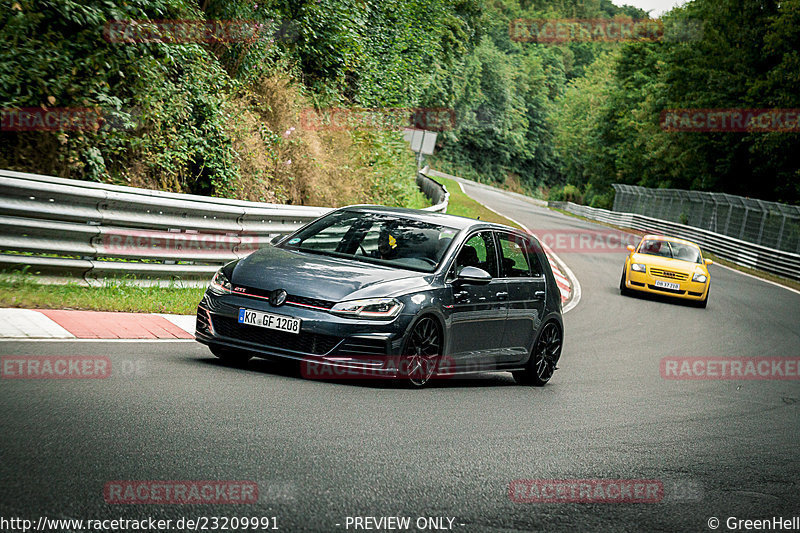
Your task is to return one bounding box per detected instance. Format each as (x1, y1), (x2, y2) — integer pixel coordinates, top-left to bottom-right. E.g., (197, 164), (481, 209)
(212, 316), (342, 355)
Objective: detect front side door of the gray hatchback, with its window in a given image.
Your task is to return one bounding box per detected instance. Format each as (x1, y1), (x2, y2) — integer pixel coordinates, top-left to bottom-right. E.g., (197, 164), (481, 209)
(448, 230), (508, 371)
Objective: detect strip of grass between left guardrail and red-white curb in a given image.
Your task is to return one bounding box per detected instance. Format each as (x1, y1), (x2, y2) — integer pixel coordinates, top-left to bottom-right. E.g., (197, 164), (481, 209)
(0, 274), (205, 315)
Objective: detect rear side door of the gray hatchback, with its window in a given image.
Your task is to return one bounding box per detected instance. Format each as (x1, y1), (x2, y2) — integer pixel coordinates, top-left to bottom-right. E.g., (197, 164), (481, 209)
(496, 231), (547, 364)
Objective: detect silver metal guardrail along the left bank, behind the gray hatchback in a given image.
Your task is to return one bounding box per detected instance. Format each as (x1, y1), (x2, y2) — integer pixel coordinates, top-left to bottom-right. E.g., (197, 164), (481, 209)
(0, 170), (449, 286)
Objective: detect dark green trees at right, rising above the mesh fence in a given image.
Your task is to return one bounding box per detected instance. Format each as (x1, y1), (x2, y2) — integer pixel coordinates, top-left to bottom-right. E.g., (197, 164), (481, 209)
(553, 0), (800, 206)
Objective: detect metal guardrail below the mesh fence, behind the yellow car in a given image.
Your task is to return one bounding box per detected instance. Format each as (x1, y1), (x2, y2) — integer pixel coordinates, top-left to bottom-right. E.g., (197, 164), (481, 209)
(548, 202), (800, 281)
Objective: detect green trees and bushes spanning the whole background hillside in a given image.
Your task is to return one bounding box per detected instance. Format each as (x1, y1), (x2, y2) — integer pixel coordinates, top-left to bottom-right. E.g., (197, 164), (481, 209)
(0, 0), (800, 206)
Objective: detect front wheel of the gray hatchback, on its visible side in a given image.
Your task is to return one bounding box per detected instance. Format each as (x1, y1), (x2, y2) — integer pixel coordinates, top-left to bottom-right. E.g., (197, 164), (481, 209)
(400, 316), (444, 388)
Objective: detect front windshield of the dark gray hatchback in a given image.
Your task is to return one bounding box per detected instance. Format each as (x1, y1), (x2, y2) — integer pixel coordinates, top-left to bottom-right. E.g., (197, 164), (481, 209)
(280, 210), (458, 272)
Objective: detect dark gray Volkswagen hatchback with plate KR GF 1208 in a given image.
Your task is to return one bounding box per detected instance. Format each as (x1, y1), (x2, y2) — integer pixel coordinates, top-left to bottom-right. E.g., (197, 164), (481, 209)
(195, 206), (564, 386)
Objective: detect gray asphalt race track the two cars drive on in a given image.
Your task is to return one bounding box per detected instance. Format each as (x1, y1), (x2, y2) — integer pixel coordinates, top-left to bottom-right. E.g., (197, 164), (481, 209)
(0, 186), (800, 532)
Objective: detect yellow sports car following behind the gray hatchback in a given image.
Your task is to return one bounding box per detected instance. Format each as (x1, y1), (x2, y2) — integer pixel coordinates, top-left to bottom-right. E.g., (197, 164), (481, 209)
(619, 235), (712, 307)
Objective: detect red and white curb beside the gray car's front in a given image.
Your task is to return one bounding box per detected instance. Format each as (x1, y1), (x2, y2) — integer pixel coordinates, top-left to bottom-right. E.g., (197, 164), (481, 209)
(0, 308), (195, 340)
